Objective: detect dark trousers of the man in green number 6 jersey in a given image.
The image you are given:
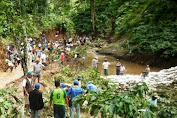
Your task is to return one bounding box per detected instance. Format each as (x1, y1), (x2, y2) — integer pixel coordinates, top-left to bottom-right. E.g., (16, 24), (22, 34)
(54, 104), (65, 118)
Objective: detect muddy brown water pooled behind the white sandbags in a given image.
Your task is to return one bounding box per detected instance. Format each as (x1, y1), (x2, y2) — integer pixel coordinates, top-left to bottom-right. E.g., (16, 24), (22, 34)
(81, 52), (160, 75)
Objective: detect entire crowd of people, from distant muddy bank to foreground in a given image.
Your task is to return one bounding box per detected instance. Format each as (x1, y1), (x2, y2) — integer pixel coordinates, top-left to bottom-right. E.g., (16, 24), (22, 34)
(2, 31), (155, 118)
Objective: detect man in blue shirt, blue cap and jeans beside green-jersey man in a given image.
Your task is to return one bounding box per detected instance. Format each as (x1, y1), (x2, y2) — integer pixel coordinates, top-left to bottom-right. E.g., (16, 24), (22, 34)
(67, 80), (83, 118)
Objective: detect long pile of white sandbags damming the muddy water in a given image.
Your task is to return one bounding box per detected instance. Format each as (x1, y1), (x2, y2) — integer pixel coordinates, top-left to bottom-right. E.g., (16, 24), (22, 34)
(107, 66), (177, 88)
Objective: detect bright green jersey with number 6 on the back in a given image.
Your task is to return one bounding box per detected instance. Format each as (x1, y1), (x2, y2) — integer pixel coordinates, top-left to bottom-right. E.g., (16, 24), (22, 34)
(50, 88), (67, 105)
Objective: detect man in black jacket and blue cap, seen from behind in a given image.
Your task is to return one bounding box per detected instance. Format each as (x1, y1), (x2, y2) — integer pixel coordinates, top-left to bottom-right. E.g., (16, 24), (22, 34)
(29, 83), (44, 118)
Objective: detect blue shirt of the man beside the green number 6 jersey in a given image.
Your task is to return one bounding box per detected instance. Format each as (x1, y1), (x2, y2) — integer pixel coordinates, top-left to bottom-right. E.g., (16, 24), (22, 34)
(67, 86), (83, 100)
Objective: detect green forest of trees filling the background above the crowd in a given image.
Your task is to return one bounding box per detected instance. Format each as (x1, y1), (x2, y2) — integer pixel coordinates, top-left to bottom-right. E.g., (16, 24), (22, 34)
(0, 0), (177, 59)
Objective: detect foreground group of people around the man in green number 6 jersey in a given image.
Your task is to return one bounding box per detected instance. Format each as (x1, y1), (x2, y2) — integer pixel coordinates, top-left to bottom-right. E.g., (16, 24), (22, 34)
(23, 72), (98, 118)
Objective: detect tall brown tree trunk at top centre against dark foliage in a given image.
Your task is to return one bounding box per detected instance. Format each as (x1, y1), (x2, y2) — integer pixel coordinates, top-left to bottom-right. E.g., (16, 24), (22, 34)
(90, 0), (96, 39)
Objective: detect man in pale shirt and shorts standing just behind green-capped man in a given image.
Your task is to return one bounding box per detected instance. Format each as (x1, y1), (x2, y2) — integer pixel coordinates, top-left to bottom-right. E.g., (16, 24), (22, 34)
(33, 60), (43, 83)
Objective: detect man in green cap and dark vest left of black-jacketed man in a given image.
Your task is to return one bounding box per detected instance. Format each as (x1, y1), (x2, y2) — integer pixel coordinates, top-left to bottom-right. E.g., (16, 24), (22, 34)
(22, 71), (33, 113)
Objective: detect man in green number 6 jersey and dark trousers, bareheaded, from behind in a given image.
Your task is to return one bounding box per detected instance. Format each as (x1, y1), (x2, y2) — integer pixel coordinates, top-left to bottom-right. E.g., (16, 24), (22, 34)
(50, 80), (67, 118)
